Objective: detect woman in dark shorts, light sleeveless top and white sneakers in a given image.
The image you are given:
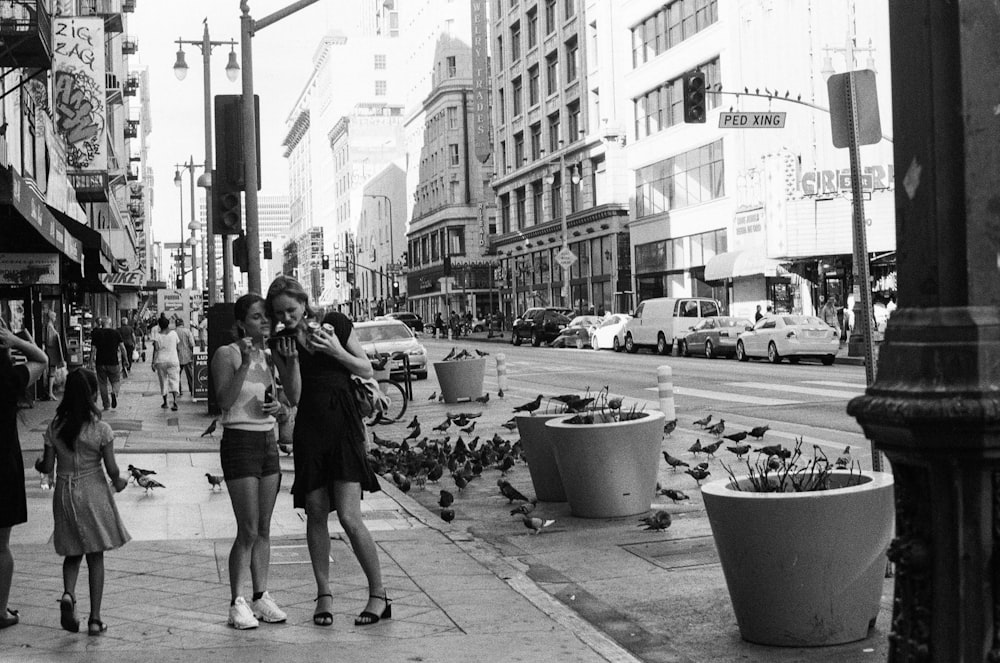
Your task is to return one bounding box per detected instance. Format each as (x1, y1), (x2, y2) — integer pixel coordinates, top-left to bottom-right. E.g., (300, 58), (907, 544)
(212, 294), (299, 629)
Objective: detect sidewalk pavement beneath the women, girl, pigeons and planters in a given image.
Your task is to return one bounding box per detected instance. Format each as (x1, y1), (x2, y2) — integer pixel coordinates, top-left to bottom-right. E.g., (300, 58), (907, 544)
(0, 338), (892, 663)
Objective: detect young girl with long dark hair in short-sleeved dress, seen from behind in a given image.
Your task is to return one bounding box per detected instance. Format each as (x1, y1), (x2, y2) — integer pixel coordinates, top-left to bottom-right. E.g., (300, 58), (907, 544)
(35, 368), (131, 635)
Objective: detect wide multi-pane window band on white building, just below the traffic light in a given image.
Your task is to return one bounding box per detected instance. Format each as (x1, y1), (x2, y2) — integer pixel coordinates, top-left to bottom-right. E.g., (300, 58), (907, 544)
(635, 140), (725, 219)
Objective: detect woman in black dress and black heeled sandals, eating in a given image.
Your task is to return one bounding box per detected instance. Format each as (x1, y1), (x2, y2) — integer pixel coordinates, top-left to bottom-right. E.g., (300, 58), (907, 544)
(267, 276), (392, 626)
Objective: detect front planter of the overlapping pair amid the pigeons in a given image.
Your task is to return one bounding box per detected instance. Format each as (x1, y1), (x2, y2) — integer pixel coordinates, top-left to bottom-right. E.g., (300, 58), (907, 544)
(545, 411), (663, 518)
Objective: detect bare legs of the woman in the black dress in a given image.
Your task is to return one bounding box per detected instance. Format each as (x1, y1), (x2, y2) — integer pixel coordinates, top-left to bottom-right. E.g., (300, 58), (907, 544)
(306, 481), (385, 615)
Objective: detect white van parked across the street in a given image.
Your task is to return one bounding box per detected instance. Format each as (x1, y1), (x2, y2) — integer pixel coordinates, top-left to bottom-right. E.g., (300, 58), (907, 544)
(625, 297), (722, 355)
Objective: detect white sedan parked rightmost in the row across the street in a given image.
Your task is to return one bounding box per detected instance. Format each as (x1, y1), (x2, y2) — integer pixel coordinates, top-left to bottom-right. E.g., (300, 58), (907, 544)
(736, 315), (840, 366)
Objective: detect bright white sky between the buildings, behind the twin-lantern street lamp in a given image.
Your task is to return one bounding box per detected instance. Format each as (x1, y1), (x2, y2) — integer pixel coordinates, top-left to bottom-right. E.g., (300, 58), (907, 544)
(126, 0), (332, 249)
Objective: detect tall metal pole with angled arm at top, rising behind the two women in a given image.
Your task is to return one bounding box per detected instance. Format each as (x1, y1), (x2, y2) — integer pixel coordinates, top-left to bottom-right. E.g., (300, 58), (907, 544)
(240, 0), (318, 293)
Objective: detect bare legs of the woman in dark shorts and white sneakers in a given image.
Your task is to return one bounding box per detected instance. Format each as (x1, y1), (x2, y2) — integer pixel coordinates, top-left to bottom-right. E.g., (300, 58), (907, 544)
(226, 474), (281, 601)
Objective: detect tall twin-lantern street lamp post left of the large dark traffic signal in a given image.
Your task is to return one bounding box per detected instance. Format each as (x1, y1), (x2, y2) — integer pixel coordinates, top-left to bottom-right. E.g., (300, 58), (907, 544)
(174, 19), (240, 306)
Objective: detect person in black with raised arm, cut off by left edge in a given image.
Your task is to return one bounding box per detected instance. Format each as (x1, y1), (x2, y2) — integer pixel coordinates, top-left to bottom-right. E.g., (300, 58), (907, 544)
(0, 318), (48, 629)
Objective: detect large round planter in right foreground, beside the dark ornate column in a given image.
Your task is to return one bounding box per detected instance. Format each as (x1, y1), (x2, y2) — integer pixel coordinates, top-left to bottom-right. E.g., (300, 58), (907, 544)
(701, 472), (895, 647)
